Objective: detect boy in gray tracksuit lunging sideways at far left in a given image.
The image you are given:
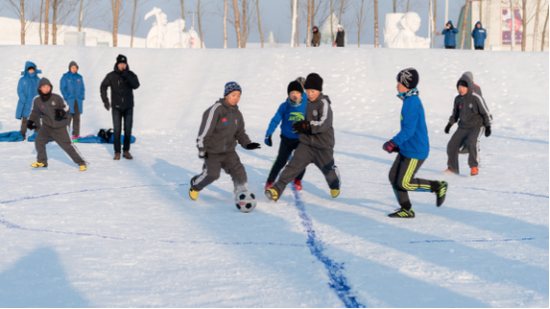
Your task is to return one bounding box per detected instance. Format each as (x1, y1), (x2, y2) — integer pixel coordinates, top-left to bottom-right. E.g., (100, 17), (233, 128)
(27, 78), (86, 171)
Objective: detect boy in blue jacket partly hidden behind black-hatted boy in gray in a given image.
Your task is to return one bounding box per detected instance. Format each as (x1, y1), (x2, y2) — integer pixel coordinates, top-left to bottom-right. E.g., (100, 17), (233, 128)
(265, 80), (307, 190)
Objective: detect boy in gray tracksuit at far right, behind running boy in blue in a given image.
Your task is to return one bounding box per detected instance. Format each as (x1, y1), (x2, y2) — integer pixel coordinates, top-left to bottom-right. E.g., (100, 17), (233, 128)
(445, 75), (492, 176)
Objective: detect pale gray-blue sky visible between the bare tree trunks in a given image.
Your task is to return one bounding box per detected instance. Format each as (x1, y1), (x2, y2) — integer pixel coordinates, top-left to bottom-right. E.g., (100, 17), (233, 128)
(0, 0), (470, 48)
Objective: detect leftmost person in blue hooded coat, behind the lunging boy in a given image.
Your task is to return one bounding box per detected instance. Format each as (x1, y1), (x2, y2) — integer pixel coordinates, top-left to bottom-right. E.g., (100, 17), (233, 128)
(15, 61), (42, 138)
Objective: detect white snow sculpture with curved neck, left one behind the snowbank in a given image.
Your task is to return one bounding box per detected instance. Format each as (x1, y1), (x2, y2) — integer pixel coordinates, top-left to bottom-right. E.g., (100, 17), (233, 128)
(145, 7), (200, 48)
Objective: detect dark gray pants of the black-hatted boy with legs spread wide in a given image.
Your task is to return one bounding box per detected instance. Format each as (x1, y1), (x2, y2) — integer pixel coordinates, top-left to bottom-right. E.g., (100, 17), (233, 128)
(271, 143), (340, 196)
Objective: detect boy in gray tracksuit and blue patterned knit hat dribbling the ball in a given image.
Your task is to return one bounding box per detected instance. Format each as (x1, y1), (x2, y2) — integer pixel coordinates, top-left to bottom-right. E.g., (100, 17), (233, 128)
(189, 82), (260, 200)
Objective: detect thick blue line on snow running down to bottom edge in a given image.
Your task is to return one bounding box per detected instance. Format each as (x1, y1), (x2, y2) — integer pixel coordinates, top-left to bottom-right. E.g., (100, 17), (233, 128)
(292, 188), (365, 308)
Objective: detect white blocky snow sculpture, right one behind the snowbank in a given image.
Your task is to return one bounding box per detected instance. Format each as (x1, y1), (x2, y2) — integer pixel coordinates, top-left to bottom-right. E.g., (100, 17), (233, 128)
(384, 12), (430, 48)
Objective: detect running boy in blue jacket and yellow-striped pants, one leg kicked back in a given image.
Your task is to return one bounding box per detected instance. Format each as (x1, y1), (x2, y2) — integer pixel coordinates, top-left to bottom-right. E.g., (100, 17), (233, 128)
(382, 68), (448, 218)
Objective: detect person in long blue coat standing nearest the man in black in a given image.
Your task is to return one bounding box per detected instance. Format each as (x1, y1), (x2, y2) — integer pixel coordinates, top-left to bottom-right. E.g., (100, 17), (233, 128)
(59, 61), (86, 137)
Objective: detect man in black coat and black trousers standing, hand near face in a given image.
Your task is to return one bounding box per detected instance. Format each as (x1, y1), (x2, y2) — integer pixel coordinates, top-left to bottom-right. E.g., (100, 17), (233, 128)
(101, 55), (139, 160)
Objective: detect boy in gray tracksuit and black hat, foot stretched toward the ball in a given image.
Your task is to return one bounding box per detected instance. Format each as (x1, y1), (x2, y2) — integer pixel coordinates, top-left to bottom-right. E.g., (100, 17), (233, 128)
(265, 73), (340, 201)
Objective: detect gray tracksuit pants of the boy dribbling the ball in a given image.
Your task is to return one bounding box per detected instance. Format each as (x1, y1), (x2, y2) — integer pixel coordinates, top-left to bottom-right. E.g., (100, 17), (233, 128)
(191, 150), (248, 194)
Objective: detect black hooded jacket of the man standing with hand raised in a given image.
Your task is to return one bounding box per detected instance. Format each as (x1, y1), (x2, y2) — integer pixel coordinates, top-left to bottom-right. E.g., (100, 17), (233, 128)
(100, 64), (139, 110)
